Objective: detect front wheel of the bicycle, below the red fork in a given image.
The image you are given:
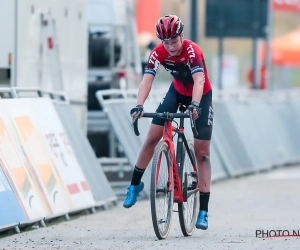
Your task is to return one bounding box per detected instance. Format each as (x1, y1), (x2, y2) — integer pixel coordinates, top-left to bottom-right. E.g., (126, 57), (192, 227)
(150, 141), (174, 240)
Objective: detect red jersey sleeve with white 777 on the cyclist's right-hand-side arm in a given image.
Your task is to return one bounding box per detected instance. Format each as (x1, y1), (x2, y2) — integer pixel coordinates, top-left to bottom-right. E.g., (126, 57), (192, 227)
(187, 43), (204, 75)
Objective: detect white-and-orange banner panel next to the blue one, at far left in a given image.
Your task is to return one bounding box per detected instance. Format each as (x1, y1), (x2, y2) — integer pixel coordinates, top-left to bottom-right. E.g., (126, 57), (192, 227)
(0, 100), (52, 220)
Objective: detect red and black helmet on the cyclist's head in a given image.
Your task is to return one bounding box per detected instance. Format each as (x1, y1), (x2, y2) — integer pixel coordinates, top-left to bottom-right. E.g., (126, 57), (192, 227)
(155, 15), (184, 41)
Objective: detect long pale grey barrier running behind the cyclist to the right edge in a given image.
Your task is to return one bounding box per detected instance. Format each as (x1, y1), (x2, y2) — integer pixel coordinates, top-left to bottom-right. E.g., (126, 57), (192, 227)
(96, 89), (300, 195)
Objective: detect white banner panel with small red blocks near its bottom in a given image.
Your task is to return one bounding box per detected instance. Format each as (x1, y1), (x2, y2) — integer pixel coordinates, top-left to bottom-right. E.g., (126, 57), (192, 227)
(26, 99), (95, 209)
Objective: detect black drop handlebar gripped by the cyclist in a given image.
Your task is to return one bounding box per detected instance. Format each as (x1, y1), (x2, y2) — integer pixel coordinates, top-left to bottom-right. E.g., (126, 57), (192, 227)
(132, 111), (198, 137)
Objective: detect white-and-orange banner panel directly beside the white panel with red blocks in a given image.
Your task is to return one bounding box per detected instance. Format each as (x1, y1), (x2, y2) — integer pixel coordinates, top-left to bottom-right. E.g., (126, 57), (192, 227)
(2, 99), (72, 215)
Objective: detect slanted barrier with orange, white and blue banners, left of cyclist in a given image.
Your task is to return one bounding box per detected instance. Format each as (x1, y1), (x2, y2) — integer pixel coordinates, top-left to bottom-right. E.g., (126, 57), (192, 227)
(0, 88), (117, 232)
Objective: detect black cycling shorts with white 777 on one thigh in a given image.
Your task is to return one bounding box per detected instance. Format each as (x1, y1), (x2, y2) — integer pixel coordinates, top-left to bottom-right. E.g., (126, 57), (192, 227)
(152, 84), (213, 141)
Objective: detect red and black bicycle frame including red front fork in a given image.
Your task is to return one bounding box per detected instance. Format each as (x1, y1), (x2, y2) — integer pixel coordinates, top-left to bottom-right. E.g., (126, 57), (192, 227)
(163, 118), (196, 203)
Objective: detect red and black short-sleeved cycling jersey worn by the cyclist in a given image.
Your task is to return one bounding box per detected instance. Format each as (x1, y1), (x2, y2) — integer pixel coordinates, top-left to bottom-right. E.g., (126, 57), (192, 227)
(145, 40), (212, 96)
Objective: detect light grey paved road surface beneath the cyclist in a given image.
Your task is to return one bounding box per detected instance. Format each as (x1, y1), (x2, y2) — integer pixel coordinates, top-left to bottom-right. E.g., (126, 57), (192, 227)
(0, 167), (300, 250)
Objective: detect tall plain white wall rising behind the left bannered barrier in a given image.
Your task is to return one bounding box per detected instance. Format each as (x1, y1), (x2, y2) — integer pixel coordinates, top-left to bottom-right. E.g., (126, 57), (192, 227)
(12, 0), (88, 130)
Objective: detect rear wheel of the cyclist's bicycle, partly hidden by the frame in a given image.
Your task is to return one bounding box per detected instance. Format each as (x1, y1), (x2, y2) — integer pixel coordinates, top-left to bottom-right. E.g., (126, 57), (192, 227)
(178, 140), (200, 236)
